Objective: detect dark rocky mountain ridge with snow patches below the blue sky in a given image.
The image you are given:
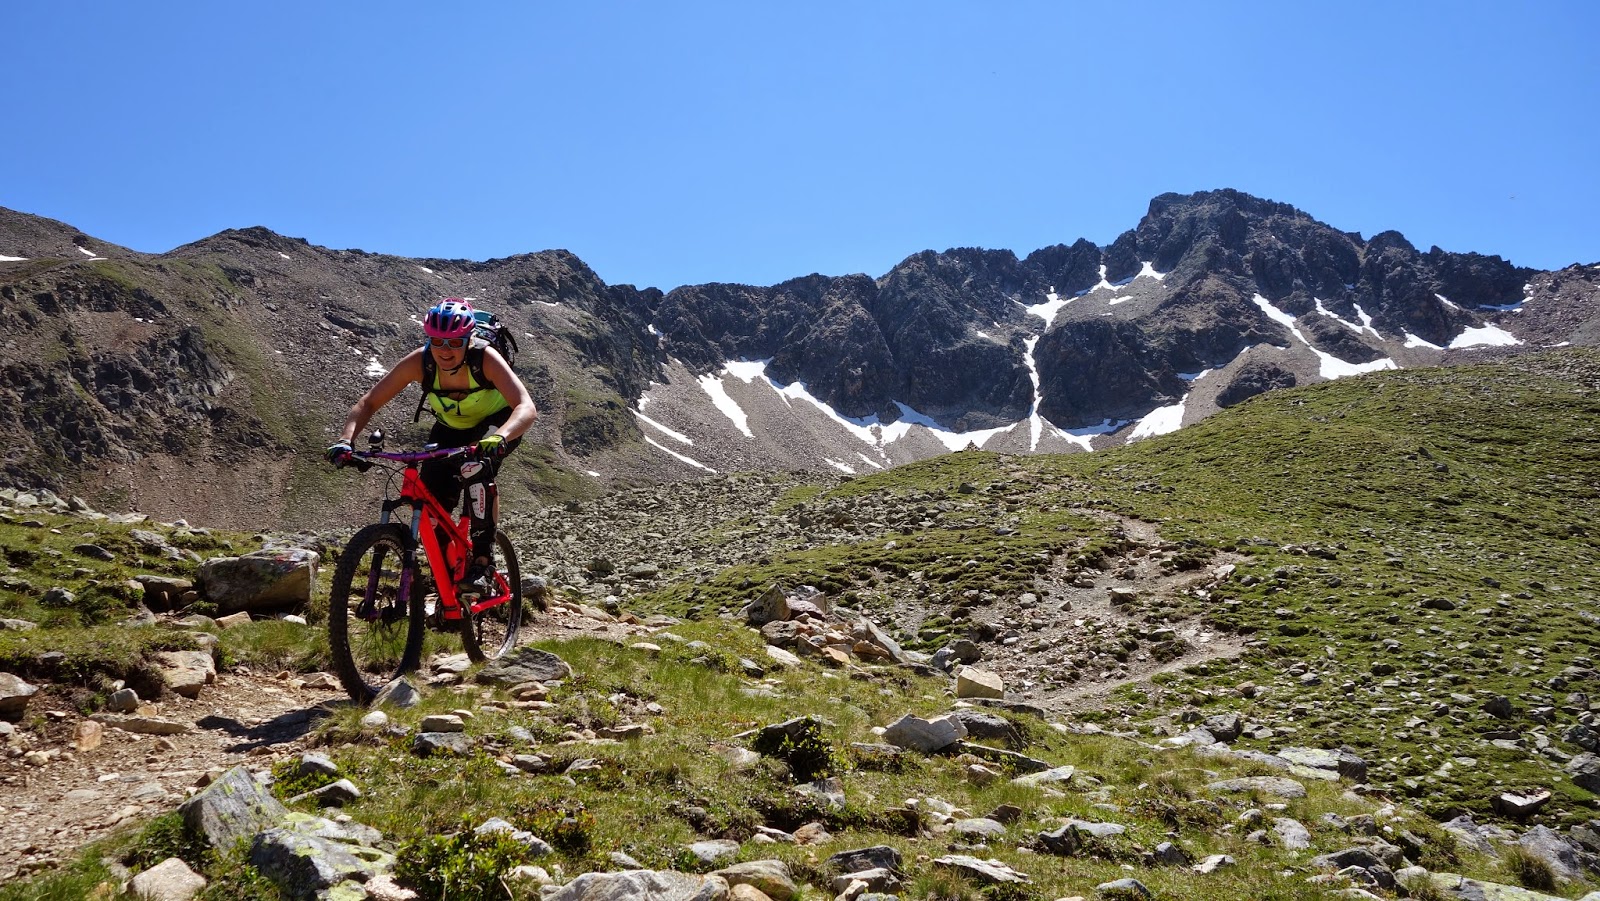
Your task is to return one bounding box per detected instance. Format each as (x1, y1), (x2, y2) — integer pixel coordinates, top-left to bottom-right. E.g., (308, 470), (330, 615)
(0, 190), (1600, 525)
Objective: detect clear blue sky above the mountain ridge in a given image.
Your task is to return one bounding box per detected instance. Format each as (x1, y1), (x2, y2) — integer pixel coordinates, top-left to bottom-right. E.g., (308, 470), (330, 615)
(0, 0), (1600, 288)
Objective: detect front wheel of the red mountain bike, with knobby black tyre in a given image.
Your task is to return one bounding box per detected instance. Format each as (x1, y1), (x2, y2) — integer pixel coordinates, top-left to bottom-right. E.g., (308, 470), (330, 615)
(328, 523), (424, 704)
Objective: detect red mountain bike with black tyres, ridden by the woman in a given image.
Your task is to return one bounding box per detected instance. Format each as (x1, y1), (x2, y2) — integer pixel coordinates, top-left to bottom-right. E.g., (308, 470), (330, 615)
(328, 432), (522, 704)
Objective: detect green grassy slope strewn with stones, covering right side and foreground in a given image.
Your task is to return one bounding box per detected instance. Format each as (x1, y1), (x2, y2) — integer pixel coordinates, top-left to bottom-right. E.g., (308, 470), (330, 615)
(0, 350), (1600, 899)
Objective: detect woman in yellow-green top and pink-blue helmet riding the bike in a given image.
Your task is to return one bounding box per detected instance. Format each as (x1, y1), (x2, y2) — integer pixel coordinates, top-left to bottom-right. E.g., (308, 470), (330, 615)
(323, 298), (539, 595)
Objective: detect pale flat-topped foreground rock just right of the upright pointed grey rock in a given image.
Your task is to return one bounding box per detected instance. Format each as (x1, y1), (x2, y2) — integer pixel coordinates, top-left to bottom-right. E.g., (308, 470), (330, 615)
(250, 815), (394, 898)
